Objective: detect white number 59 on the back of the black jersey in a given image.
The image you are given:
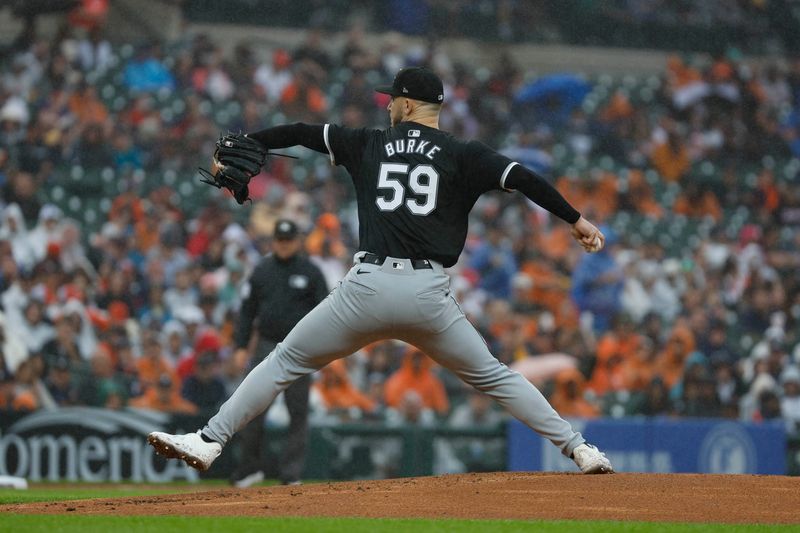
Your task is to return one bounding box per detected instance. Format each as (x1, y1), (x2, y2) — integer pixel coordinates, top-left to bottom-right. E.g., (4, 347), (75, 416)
(375, 163), (439, 216)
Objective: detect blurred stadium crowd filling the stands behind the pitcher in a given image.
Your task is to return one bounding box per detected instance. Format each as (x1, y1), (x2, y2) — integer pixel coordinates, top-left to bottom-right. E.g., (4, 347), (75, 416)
(0, 8), (800, 448)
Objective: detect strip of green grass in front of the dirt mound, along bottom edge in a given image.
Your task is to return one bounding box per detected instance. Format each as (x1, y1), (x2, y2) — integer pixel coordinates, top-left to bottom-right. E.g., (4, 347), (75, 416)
(0, 515), (800, 533)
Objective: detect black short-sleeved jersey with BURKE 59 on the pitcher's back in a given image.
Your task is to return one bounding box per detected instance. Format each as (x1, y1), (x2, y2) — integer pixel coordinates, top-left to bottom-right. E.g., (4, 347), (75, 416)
(324, 122), (517, 267)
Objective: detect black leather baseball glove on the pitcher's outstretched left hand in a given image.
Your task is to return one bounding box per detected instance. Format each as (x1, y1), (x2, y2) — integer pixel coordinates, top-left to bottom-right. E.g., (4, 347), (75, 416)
(199, 132), (268, 205)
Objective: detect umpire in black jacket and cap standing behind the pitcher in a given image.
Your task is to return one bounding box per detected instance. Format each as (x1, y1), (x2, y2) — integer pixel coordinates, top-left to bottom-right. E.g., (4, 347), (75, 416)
(231, 220), (328, 487)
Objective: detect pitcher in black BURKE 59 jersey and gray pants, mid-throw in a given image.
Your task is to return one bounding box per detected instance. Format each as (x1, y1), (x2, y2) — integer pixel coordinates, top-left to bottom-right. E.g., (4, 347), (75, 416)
(148, 67), (613, 474)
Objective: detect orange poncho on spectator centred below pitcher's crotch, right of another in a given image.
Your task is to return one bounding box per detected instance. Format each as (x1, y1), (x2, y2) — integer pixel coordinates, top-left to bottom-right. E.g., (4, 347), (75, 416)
(384, 348), (450, 415)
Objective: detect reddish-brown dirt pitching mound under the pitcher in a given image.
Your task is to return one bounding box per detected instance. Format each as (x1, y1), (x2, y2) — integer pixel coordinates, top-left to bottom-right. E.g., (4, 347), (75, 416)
(6, 472), (800, 523)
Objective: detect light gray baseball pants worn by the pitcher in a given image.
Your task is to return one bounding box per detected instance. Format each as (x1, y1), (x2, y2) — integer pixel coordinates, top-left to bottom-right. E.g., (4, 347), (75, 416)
(203, 252), (585, 456)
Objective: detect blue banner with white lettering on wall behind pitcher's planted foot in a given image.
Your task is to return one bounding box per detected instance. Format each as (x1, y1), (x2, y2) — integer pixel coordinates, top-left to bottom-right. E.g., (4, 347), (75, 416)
(508, 418), (786, 474)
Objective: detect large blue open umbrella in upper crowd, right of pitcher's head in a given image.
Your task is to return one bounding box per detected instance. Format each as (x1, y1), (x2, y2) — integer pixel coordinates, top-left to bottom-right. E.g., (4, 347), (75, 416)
(514, 74), (592, 126)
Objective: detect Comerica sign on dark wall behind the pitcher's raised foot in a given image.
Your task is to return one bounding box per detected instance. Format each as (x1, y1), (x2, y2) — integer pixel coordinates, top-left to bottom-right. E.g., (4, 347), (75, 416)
(0, 407), (198, 483)
